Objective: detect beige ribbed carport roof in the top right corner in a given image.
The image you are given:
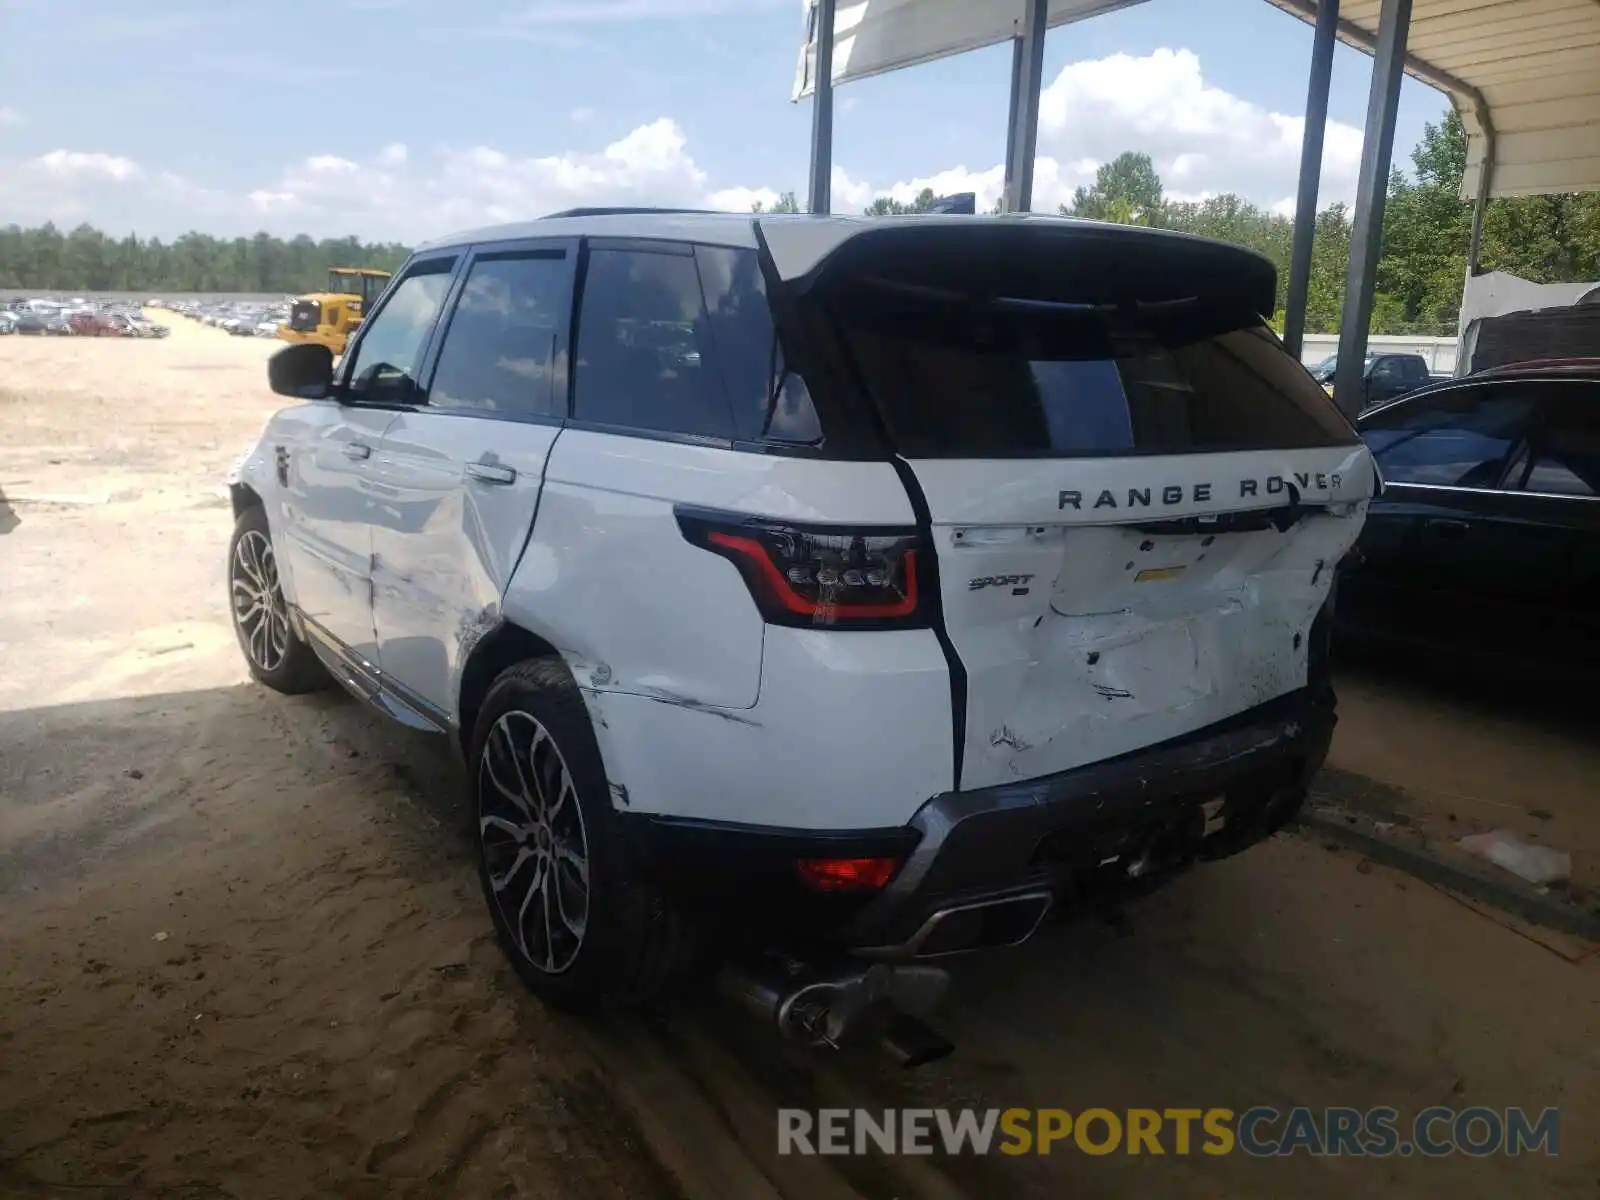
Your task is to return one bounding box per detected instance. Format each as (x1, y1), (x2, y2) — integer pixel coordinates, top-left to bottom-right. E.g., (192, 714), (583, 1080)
(1269, 0), (1600, 200)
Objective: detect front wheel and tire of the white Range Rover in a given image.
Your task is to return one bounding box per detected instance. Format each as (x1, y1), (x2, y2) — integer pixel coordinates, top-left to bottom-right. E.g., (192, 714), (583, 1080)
(227, 506), (326, 693)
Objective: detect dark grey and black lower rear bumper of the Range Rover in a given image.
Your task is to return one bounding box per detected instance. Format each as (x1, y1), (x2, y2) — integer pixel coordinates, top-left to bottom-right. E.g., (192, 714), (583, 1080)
(624, 685), (1334, 958)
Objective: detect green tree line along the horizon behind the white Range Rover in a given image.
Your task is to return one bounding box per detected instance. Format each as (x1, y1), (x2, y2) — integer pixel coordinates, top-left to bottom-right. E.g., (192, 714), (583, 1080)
(0, 110), (1600, 334)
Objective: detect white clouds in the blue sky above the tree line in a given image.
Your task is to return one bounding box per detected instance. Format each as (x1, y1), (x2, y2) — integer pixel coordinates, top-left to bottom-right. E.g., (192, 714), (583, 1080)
(0, 50), (1360, 242)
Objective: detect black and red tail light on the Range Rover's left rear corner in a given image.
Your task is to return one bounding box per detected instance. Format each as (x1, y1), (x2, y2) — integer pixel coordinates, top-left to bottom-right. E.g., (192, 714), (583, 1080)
(677, 509), (933, 629)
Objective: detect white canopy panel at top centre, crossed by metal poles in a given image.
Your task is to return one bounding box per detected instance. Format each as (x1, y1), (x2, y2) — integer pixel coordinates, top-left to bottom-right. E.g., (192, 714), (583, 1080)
(794, 0), (1144, 99)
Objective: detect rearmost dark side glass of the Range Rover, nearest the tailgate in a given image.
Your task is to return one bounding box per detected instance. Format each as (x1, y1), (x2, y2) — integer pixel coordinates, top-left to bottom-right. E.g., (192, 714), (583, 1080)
(694, 246), (822, 445)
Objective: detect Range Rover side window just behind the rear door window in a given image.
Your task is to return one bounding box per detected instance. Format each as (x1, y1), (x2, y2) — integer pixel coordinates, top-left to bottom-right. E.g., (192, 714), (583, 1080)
(573, 246), (733, 438)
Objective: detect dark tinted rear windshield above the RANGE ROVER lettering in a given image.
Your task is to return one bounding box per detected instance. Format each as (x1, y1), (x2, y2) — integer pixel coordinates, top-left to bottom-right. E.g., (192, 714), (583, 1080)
(830, 285), (1355, 458)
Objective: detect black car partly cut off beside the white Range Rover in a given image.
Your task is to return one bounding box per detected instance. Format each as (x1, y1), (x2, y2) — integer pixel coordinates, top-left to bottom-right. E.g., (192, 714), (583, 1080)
(1336, 363), (1600, 678)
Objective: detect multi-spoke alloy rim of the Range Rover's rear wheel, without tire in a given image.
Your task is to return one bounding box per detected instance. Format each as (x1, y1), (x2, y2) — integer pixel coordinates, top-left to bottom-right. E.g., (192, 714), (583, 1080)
(478, 710), (589, 974)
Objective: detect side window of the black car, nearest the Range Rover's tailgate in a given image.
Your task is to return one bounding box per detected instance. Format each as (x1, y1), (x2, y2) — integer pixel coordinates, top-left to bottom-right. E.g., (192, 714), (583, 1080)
(1362, 387), (1533, 488)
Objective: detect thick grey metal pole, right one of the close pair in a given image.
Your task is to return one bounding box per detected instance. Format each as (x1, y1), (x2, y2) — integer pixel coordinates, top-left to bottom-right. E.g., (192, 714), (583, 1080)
(1333, 0), (1411, 416)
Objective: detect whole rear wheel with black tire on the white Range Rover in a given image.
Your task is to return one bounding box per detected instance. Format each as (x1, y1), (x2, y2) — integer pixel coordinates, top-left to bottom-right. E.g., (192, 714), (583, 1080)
(469, 658), (699, 1011)
